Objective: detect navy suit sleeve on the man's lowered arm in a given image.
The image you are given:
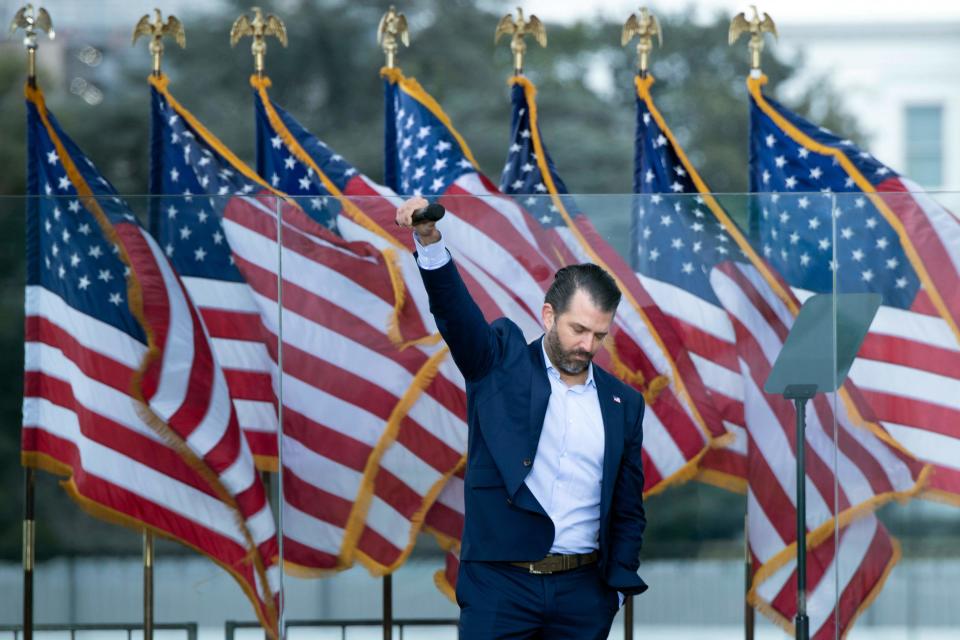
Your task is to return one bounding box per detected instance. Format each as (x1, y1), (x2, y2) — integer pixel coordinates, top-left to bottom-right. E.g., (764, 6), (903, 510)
(608, 398), (647, 595)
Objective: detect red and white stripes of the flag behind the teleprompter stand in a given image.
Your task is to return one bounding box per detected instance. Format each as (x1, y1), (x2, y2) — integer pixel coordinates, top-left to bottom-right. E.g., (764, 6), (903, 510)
(641, 86), (932, 638)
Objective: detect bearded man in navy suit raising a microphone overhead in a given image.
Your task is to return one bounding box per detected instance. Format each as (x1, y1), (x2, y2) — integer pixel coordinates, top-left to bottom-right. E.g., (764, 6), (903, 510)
(396, 198), (647, 640)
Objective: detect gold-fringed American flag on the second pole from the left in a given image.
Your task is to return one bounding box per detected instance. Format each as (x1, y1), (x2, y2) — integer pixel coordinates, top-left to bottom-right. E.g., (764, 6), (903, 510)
(151, 71), (460, 575)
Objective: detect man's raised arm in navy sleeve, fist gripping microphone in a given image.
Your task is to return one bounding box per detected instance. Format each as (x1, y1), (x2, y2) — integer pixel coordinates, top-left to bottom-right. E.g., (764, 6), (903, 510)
(396, 198), (500, 381)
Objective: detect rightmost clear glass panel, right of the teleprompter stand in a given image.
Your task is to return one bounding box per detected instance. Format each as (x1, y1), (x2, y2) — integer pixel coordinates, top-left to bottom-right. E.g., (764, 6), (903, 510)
(835, 193), (960, 638)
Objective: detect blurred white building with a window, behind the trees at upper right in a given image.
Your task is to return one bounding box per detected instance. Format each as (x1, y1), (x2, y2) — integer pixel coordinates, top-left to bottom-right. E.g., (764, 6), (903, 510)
(767, 23), (960, 191)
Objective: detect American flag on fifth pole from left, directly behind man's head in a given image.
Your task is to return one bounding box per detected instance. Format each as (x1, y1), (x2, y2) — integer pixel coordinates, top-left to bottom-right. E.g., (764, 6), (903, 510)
(500, 76), (729, 495)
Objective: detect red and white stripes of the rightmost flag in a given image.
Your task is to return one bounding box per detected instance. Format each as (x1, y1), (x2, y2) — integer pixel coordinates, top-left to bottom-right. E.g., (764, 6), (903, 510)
(850, 178), (960, 502)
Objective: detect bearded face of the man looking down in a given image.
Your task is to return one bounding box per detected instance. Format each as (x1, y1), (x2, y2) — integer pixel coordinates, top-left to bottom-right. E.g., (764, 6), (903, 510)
(541, 289), (613, 376)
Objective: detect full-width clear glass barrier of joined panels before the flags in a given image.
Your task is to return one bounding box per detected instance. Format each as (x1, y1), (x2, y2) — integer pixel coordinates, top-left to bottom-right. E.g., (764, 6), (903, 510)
(9, 193), (960, 638)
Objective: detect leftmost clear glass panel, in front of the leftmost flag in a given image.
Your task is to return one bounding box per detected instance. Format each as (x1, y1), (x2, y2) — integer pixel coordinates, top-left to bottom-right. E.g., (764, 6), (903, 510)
(14, 192), (279, 638)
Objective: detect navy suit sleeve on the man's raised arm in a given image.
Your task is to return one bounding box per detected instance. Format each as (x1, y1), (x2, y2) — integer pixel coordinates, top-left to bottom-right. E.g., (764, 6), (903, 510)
(420, 260), (501, 381)
